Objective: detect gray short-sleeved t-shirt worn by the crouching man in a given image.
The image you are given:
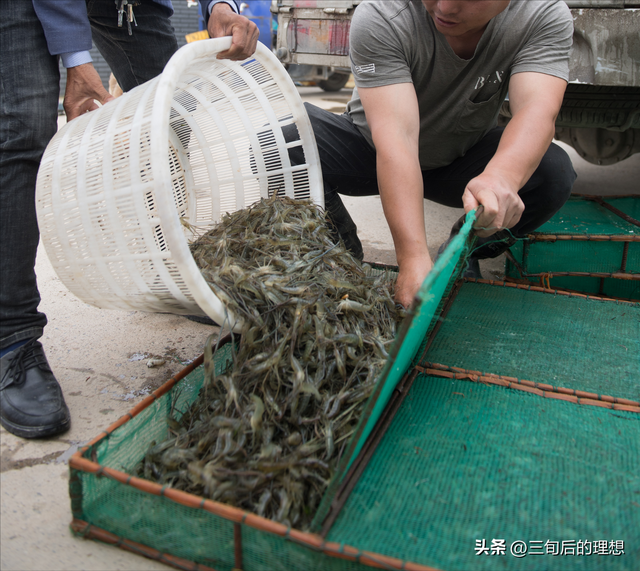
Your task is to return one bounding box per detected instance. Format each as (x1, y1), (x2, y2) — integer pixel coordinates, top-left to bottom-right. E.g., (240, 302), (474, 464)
(347, 0), (573, 170)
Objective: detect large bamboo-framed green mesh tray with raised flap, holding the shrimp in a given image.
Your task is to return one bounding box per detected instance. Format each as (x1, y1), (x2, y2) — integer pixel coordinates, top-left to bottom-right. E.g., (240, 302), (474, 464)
(70, 212), (640, 571)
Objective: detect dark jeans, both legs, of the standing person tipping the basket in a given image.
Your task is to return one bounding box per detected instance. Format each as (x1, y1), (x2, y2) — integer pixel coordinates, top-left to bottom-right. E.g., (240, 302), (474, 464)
(0, 0), (178, 349)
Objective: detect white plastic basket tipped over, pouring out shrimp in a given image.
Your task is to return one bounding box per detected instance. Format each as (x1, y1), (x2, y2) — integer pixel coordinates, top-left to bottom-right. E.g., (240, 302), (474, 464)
(36, 38), (324, 328)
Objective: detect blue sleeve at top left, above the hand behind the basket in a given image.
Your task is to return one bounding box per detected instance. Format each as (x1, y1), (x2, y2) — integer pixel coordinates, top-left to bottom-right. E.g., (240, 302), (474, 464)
(31, 0), (92, 56)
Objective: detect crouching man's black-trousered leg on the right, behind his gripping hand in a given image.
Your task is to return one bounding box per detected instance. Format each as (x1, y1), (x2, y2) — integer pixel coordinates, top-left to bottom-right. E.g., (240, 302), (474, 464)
(422, 128), (576, 259)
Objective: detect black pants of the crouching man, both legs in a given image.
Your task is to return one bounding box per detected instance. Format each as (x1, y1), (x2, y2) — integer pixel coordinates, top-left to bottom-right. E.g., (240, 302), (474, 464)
(292, 103), (577, 259)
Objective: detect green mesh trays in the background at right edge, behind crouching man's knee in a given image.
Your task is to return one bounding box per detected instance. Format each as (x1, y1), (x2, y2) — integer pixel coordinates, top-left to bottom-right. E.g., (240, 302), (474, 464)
(505, 196), (640, 300)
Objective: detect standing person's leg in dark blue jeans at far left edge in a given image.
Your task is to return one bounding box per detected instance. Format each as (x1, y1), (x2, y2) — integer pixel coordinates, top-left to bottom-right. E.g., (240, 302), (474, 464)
(0, 2), (60, 349)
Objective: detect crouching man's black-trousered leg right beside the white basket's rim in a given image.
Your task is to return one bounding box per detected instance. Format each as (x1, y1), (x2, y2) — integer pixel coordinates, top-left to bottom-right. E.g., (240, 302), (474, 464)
(285, 103), (378, 260)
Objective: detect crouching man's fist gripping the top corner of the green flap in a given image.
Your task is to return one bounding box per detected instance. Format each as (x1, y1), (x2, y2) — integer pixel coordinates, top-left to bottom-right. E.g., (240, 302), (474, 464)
(462, 171), (524, 238)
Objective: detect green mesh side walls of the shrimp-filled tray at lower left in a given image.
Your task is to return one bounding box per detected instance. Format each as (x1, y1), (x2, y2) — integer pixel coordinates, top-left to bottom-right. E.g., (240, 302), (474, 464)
(69, 344), (408, 571)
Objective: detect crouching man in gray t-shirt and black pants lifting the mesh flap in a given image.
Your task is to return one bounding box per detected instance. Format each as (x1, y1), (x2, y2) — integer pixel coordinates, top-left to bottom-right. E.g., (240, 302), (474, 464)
(292, 0), (575, 305)
